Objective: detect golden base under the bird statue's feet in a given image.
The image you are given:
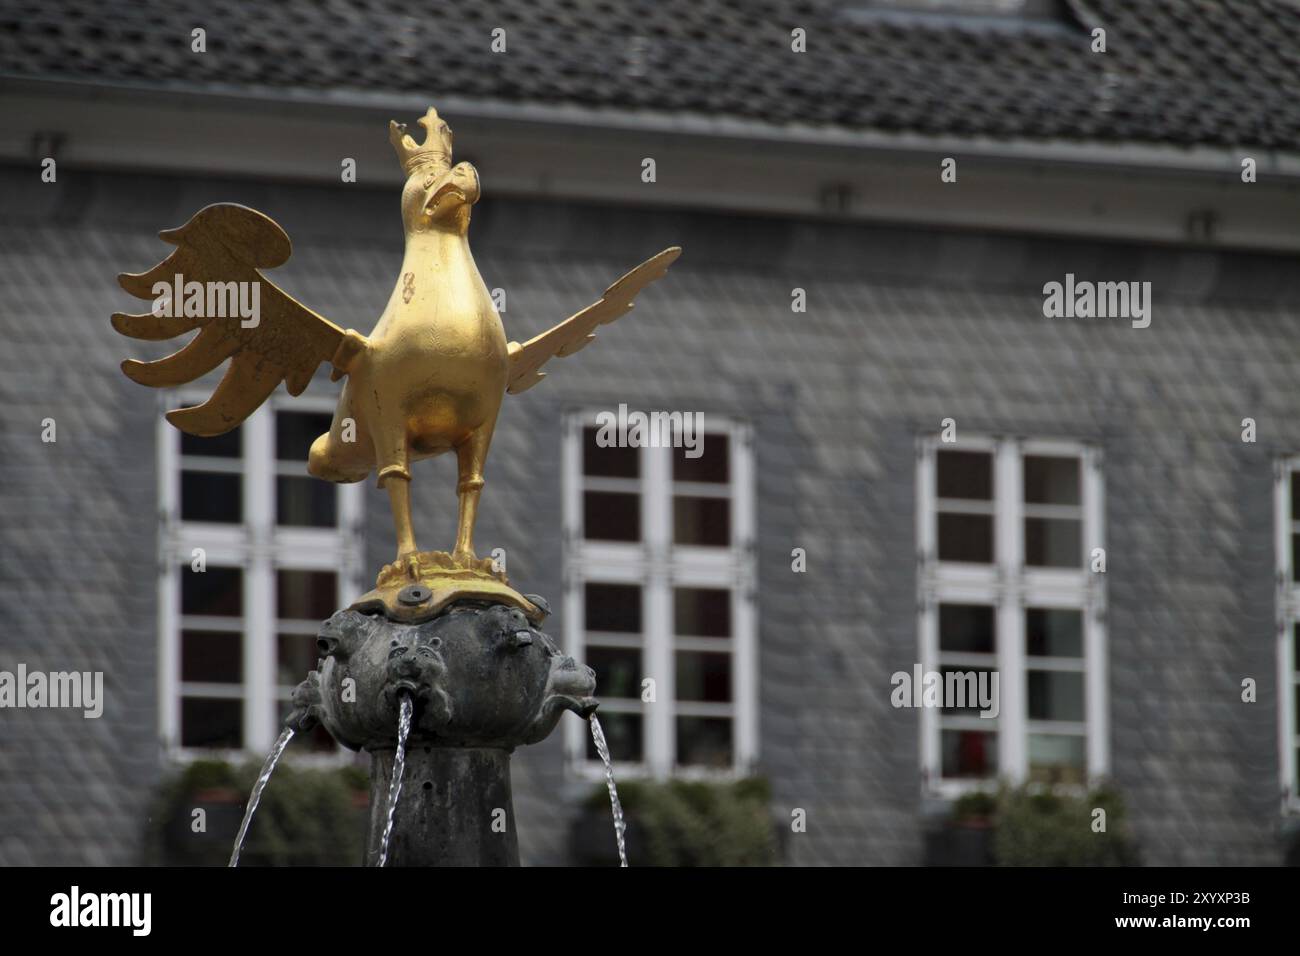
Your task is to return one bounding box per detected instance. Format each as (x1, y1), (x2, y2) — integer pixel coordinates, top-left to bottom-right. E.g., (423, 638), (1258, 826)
(348, 551), (546, 624)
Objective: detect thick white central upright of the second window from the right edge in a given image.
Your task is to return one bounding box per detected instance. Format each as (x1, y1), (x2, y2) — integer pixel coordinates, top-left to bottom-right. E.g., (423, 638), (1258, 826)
(993, 441), (1028, 782)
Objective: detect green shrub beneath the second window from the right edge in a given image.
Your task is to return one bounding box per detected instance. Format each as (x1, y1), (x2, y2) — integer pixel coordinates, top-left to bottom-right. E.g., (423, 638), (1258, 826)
(993, 787), (1139, 866)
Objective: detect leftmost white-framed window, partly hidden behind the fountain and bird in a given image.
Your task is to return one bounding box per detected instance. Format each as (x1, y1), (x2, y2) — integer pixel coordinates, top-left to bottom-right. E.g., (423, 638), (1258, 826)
(159, 395), (360, 753)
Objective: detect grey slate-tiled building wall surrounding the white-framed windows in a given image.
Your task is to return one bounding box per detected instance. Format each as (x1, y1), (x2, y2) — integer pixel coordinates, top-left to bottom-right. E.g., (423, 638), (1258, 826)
(0, 170), (1300, 864)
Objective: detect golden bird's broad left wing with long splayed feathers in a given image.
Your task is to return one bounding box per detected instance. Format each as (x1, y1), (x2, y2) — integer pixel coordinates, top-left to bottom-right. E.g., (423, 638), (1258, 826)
(113, 203), (364, 436)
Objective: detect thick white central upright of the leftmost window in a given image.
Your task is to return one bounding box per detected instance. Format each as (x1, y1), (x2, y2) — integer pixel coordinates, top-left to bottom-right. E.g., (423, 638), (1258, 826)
(243, 406), (276, 753)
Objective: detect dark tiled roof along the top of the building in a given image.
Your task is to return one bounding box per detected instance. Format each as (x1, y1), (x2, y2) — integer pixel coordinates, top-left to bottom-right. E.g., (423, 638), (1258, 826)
(0, 0), (1300, 148)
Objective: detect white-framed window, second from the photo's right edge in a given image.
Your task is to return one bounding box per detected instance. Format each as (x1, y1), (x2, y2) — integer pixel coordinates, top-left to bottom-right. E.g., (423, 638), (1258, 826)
(917, 437), (1108, 793)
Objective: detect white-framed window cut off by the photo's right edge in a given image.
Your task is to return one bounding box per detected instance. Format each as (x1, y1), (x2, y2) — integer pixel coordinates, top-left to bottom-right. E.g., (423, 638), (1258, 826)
(1273, 457), (1300, 810)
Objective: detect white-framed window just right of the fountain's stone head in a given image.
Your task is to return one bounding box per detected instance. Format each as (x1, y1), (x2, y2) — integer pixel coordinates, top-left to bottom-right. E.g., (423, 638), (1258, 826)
(564, 414), (758, 777)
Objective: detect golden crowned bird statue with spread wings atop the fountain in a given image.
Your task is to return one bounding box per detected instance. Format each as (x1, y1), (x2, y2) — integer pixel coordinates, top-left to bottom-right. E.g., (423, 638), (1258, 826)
(112, 107), (681, 615)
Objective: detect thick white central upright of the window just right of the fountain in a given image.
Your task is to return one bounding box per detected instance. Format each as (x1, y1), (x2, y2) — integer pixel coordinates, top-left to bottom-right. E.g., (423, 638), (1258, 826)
(641, 447), (677, 779)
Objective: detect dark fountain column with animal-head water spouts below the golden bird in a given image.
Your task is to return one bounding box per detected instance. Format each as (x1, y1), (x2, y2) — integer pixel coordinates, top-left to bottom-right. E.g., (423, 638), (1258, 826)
(290, 589), (597, 866)
